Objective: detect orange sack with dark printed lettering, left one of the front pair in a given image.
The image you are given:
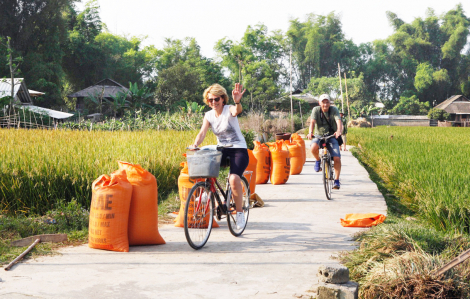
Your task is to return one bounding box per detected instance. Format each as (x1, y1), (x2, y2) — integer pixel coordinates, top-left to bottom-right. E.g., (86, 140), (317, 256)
(88, 170), (132, 252)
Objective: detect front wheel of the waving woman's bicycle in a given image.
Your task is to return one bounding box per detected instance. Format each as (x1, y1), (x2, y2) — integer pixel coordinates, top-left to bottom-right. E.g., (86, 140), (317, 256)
(184, 182), (214, 249)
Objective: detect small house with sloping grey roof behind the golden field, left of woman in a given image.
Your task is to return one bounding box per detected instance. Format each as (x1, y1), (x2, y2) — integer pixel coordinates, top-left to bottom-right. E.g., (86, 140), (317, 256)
(67, 78), (129, 110)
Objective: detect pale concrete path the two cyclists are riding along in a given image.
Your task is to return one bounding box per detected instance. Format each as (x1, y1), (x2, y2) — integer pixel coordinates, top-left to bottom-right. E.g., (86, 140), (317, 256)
(0, 152), (386, 299)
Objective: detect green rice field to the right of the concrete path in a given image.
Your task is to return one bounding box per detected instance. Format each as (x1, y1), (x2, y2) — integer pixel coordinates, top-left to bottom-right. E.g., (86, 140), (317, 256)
(348, 126), (470, 234)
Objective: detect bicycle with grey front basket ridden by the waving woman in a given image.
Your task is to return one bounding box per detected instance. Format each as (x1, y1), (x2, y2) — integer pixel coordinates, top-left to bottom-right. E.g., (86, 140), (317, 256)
(184, 145), (250, 250)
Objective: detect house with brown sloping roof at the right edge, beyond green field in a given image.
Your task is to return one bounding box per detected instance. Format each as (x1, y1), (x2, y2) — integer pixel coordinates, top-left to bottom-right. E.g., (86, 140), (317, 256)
(434, 95), (470, 127)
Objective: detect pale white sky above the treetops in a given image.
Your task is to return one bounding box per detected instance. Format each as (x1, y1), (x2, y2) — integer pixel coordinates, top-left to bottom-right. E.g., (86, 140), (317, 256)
(77, 0), (470, 58)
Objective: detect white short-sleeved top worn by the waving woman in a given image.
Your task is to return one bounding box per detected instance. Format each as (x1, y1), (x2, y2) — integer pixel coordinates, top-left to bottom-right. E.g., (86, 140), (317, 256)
(204, 105), (247, 148)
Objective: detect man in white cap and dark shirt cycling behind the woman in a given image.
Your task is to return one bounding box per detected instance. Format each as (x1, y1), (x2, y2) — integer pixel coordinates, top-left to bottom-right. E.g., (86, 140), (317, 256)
(307, 94), (343, 189)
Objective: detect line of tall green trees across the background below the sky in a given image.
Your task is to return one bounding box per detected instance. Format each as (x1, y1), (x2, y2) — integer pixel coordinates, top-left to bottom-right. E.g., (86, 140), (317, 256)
(0, 0), (470, 114)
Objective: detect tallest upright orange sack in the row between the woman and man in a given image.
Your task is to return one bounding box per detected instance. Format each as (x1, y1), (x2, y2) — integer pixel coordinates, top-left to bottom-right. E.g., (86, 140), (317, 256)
(269, 140), (290, 185)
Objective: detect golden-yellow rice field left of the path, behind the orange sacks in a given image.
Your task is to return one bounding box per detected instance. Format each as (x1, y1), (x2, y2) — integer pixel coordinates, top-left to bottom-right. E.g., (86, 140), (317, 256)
(0, 129), (216, 214)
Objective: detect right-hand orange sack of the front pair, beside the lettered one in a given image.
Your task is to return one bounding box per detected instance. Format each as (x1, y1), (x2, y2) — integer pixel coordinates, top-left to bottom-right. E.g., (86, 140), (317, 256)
(118, 161), (165, 245)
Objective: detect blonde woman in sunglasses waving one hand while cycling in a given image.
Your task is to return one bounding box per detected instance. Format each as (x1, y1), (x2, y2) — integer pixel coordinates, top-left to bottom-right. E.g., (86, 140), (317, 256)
(191, 83), (249, 231)
